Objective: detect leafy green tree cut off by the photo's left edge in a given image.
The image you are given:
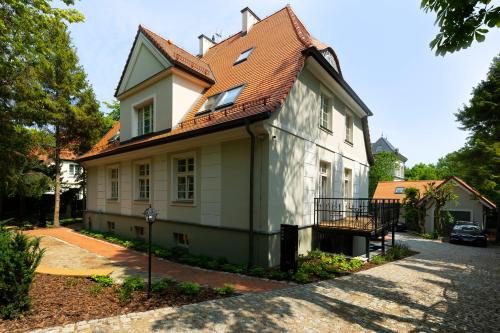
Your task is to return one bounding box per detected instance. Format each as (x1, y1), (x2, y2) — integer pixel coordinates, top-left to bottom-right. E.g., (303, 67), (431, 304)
(0, 0), (83, 212)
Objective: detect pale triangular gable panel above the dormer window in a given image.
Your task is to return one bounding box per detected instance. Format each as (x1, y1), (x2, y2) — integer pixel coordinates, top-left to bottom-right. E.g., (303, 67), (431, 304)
(118, 33), (171, 94)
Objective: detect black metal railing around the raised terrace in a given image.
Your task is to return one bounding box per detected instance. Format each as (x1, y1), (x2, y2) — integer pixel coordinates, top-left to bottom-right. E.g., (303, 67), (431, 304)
(314, 198), (400, 232)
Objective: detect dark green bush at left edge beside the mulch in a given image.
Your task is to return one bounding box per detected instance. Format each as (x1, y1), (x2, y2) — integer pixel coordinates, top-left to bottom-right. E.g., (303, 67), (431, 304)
(0, 230), (44, 319)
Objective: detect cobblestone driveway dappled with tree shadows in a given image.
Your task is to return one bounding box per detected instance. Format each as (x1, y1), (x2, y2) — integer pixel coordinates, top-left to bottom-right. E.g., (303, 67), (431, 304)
(32, 236), (500, 332)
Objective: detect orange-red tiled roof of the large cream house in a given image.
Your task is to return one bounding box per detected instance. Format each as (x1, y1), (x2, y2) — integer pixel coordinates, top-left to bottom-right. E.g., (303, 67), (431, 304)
(81, 6), (342, 160)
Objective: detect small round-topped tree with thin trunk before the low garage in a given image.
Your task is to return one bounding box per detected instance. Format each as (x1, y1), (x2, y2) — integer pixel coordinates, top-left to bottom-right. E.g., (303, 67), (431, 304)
(424, 182), (458, 235)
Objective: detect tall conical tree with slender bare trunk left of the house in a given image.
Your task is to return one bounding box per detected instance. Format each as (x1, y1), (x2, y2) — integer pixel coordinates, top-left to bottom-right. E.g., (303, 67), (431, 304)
(37, 23), (102, 226)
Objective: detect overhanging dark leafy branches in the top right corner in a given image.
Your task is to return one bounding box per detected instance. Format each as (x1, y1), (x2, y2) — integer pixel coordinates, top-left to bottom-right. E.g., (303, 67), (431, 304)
(421, 0), (500, 56)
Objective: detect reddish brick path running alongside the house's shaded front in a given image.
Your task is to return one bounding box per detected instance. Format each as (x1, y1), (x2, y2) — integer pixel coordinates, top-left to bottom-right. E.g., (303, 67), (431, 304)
(27, 227), (288, 292)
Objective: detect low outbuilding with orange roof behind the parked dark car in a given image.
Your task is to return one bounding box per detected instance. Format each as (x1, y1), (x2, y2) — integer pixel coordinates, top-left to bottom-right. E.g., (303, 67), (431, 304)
(373, 176), (496, 233)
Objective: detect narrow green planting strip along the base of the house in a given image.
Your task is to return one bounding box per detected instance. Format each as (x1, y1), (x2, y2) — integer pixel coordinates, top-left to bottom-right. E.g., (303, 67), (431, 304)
(80, 229), (413, 283)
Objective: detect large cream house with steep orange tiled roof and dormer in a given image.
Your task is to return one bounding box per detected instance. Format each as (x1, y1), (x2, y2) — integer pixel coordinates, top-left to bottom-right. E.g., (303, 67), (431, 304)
(78, 6), (372, 266)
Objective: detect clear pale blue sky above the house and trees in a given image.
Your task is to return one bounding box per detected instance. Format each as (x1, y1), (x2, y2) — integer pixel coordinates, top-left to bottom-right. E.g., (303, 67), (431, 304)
(66, 0), (500, 166)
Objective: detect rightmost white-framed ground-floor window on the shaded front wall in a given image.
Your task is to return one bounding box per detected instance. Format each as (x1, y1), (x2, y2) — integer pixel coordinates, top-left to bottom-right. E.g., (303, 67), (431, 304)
(174, 157), (195, 202)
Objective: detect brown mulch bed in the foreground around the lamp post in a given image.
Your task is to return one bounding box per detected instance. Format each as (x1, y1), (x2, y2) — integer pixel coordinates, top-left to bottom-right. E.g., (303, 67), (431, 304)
(0, 274), (227, 332)
